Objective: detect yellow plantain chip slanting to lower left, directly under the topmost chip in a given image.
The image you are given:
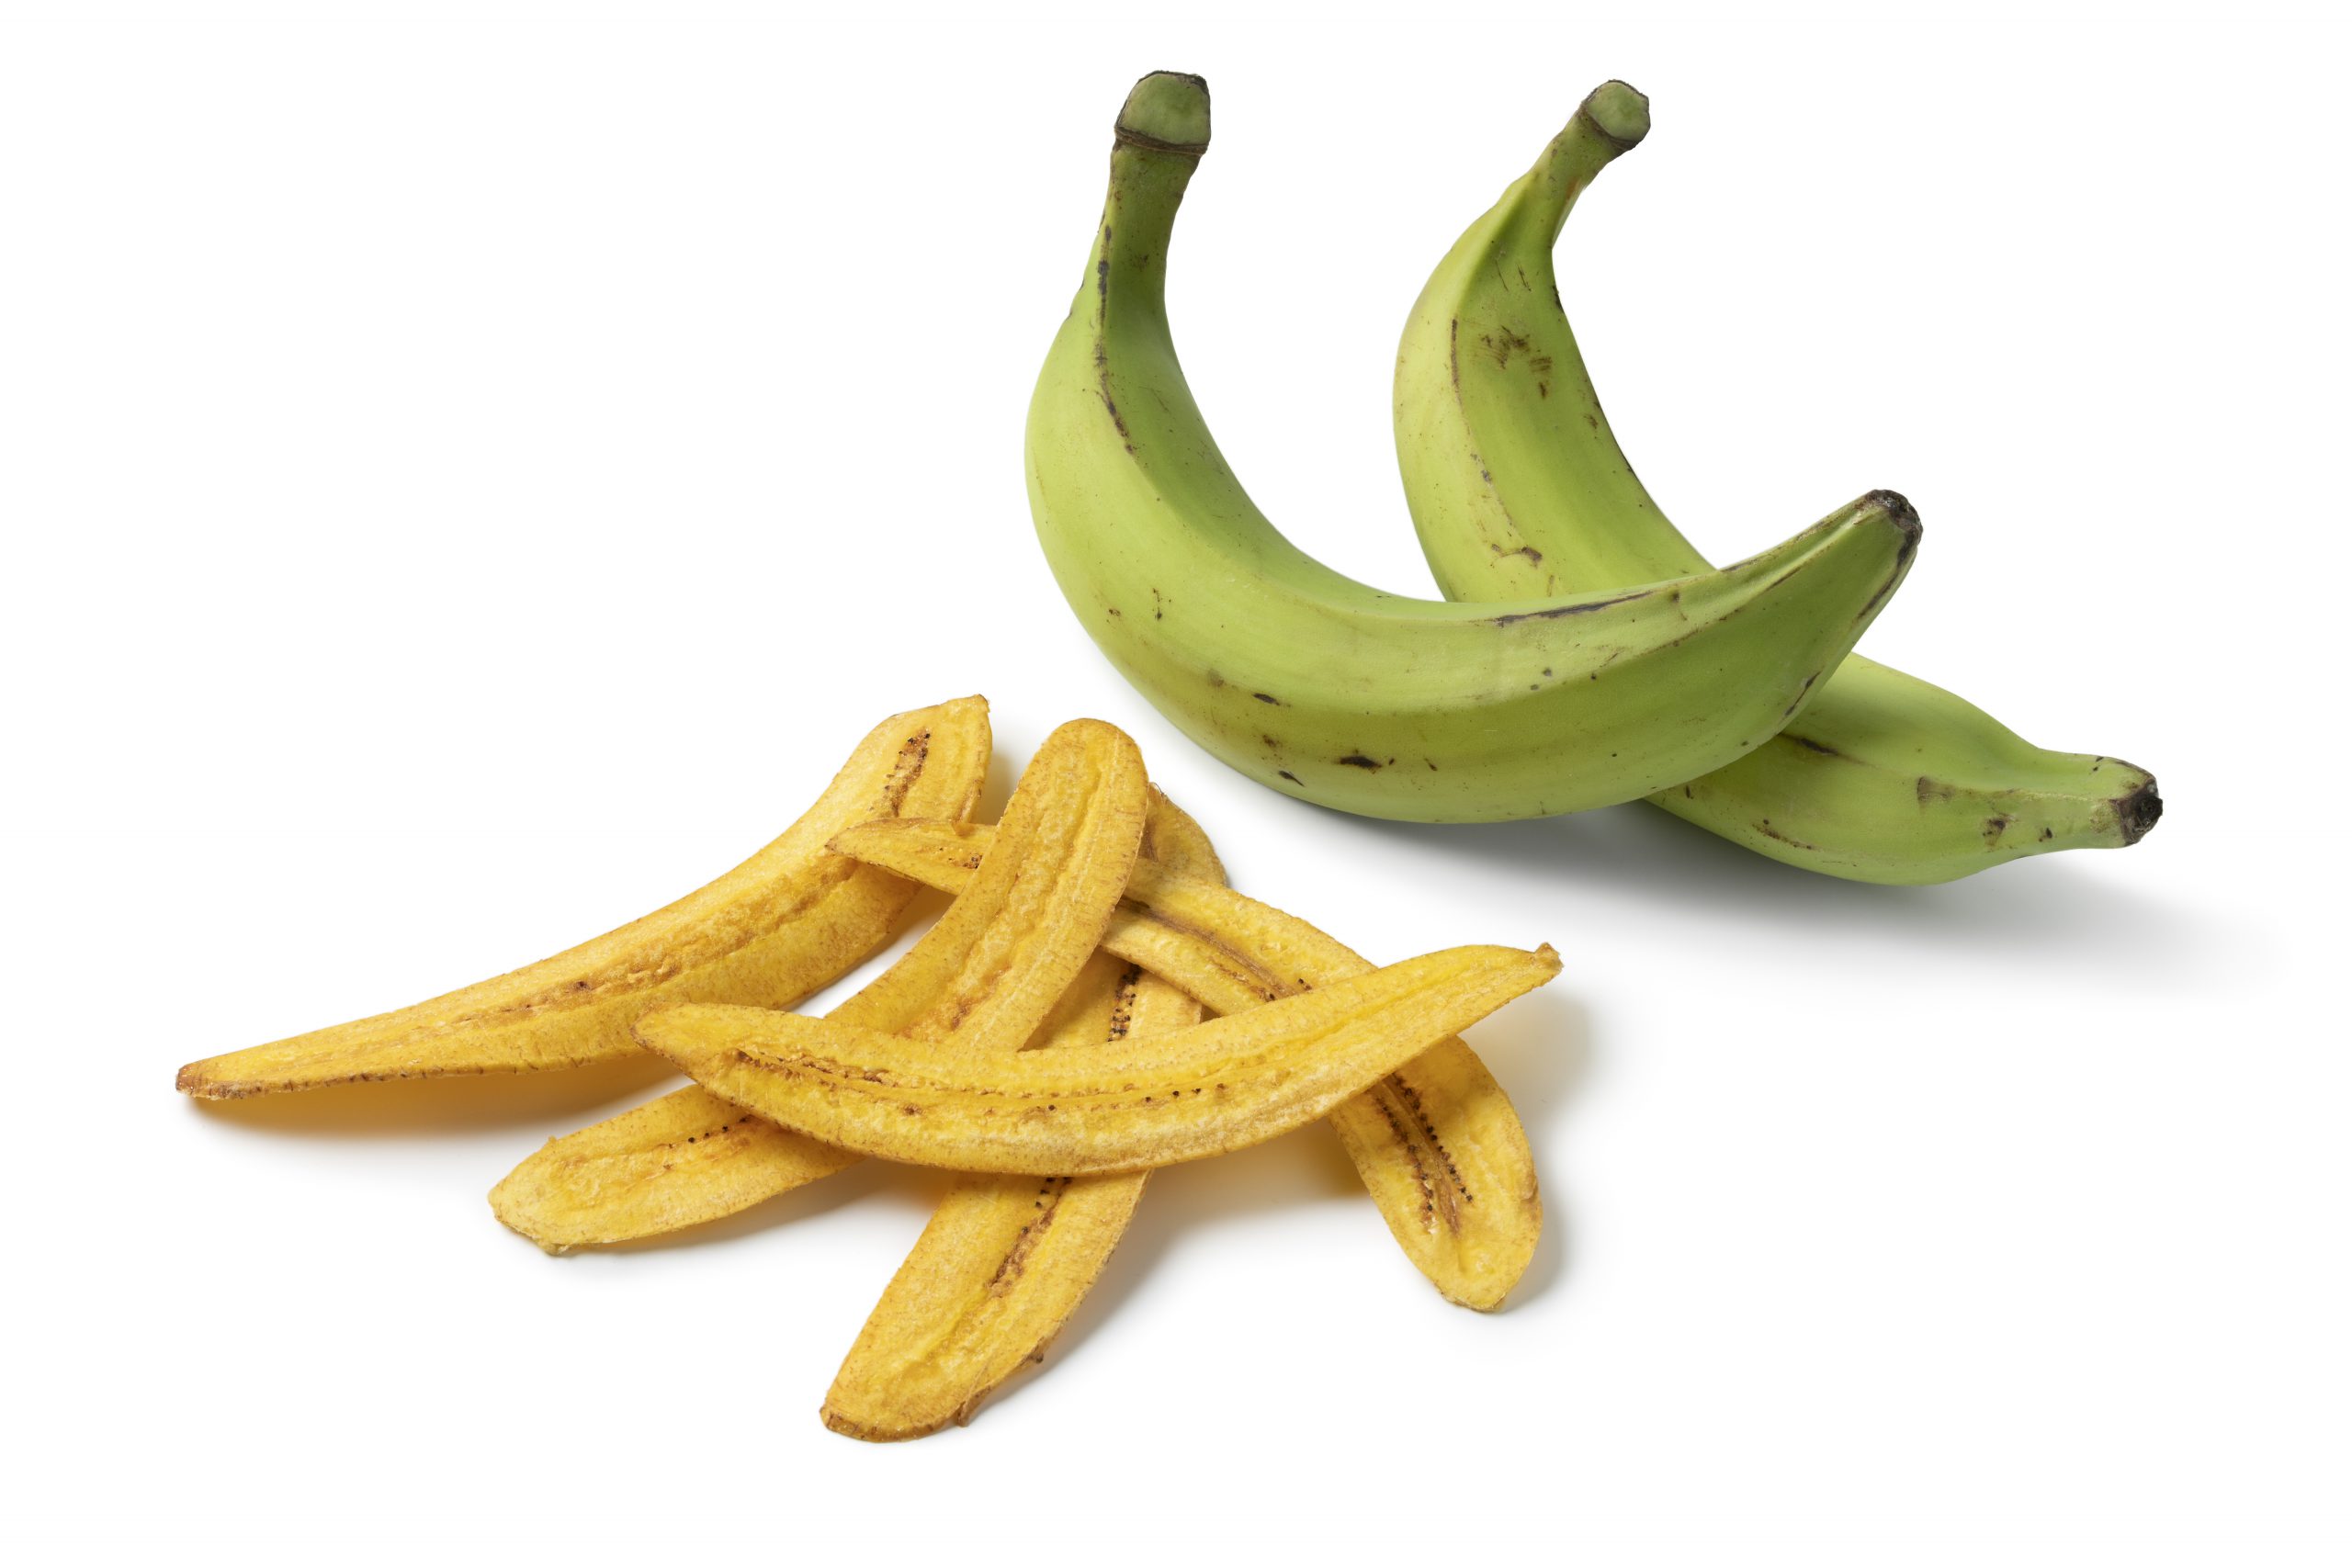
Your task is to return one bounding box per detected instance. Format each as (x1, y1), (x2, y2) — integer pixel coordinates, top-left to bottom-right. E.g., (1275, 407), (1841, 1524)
(489, 719), (1148, 1251)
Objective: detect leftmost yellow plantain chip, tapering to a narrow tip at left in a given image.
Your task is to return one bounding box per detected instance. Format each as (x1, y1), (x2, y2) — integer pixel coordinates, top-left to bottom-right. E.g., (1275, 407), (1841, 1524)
(179, 696), (988, 1100)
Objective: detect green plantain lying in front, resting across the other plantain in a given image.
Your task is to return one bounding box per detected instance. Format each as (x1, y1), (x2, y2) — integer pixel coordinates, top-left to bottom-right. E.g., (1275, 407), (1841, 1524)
(1028, 73), (1919, 823)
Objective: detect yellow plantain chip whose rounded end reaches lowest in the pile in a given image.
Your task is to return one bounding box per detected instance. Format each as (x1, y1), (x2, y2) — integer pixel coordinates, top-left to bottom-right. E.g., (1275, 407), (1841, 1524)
(818, 790), (1226, 1443)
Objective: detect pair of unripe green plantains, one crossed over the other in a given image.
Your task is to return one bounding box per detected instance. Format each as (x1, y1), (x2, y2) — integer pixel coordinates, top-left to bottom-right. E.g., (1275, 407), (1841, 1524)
(1028, 71), (2162, 884)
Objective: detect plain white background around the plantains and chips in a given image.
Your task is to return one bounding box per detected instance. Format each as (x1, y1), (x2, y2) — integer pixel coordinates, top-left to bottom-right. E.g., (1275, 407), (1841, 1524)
(0, 5), (2352, 1563)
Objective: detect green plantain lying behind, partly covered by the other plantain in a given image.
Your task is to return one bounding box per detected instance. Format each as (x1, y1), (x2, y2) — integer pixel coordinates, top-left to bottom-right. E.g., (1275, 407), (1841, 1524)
(1397, 83), (2164, 884)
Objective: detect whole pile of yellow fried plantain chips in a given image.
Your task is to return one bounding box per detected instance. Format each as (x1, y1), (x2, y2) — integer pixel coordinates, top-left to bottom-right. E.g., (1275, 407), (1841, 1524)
(179, 696), (1559, 1441)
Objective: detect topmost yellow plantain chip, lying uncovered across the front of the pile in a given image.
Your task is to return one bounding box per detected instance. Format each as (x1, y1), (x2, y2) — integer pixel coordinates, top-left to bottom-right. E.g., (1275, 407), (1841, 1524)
(638, 944), (1559, 1176)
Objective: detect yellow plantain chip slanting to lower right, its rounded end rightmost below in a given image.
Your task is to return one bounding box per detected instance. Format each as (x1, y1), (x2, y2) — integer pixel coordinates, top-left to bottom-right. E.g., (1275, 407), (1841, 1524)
(835, 818), (1543, 1312)
